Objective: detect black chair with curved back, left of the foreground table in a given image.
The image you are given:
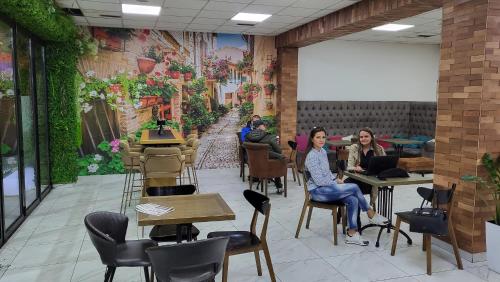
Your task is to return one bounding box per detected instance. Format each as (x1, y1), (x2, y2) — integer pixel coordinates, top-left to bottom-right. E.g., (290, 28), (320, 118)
(84, 211), (158, 282)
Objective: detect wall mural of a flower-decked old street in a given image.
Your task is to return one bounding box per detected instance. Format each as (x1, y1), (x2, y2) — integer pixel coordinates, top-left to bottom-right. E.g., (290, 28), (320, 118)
(76, 27), (276, 175)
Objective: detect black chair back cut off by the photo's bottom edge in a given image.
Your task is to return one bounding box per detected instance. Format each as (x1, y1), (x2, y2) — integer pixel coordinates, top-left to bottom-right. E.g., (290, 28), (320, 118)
(146, 238), (229, 282)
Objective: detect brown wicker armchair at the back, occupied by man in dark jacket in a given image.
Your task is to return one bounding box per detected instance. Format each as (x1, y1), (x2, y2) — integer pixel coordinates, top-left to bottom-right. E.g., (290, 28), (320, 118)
(243, 142), (288, 198)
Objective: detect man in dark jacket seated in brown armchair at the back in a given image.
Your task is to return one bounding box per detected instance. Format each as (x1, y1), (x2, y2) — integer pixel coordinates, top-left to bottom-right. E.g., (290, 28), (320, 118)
(245, 120), (285, 193)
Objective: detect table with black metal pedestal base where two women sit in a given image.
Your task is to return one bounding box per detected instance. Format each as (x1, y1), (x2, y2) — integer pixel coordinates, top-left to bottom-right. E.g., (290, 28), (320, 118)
(345, 172), (432, 247)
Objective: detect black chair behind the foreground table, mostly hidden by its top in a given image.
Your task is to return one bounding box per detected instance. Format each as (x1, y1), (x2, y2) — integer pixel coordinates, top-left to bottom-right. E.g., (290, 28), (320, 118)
(146, 185), (200, 243)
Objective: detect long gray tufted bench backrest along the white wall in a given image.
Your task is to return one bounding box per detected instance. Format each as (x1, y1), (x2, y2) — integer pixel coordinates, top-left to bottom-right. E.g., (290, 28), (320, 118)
(297, 101), (436, 137)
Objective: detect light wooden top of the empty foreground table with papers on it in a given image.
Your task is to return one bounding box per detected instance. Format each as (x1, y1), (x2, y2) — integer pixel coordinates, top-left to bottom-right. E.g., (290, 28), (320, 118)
(137, 193), (236, 226)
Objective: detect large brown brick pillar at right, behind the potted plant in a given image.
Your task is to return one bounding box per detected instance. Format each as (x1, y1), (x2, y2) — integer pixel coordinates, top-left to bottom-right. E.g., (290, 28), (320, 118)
(434, 0), (500, 253)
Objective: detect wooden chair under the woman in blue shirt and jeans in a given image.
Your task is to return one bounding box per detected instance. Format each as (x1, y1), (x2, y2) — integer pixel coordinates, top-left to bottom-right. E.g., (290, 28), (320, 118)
(295, 170), (347, 245)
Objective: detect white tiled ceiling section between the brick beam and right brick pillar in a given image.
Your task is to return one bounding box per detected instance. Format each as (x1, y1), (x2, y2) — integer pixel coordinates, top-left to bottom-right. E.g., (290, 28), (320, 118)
(338, 9), (443, 44)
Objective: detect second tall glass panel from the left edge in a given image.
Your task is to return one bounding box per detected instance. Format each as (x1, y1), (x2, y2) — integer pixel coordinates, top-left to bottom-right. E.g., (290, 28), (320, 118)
(16, 31), (37, 207)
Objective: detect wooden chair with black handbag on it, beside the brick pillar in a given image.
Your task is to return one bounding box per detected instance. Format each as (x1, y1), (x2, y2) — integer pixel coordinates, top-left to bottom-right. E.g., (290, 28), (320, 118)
(391, 184), (463, 275)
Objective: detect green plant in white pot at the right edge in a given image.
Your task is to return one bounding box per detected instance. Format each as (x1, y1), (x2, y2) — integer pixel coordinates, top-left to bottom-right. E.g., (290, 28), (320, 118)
(462, 153), (500, 273)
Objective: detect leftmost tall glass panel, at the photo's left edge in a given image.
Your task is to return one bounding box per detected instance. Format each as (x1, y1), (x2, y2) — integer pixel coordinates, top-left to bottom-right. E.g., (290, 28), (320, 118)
(0, 21), (21, 228)
